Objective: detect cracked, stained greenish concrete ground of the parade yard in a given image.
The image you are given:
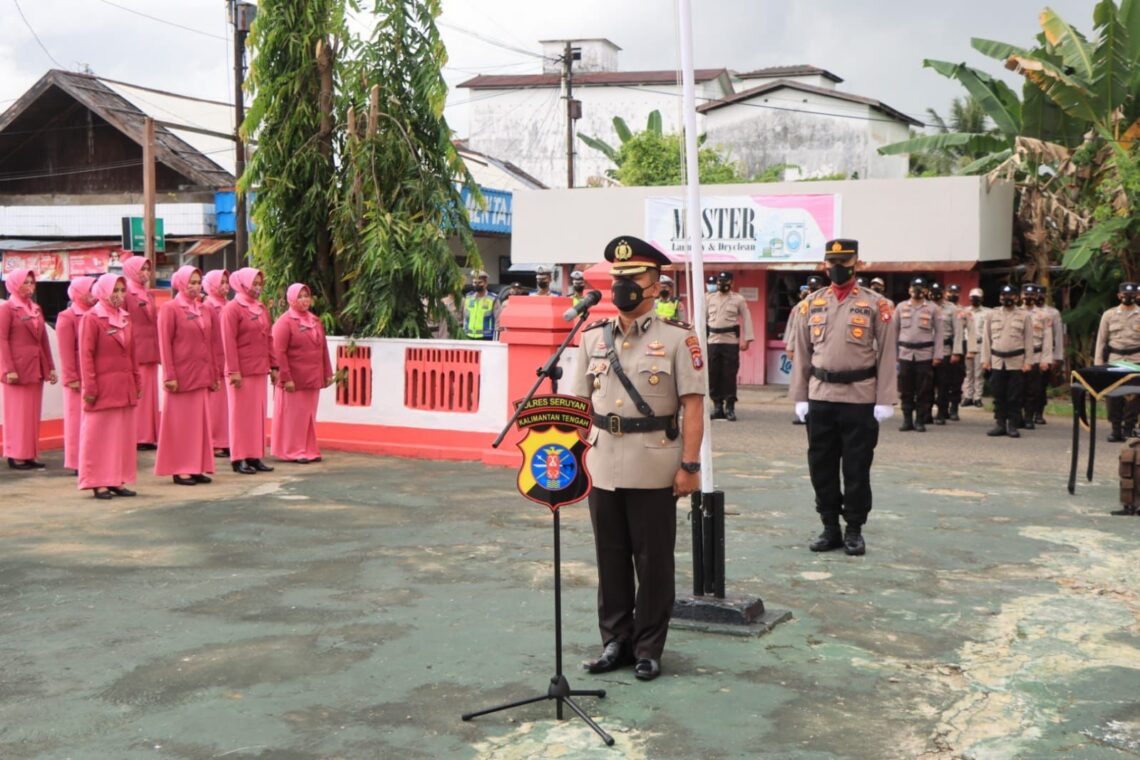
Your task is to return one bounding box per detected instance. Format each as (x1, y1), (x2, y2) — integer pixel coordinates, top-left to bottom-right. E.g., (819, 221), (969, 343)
(0, 391), (1140, 760)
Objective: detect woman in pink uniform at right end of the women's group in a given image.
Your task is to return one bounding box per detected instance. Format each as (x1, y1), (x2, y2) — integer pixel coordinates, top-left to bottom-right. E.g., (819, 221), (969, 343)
(269, 283), (333, 465)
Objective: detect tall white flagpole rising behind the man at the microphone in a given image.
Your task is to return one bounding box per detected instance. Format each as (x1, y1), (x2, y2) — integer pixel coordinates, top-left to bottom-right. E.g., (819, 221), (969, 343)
(677, 0), (714, 493)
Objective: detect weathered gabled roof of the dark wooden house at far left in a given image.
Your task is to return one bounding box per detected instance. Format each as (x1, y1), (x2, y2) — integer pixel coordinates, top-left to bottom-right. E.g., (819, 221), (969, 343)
(0, 70), (234, 188)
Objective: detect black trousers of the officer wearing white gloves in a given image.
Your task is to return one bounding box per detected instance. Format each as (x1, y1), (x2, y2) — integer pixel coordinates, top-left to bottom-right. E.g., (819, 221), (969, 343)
(807, 401), (879, 526)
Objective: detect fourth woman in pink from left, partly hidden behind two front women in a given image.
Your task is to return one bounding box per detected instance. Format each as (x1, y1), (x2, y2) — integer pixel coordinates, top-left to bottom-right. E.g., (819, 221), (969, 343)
(123, 256), (162, 451)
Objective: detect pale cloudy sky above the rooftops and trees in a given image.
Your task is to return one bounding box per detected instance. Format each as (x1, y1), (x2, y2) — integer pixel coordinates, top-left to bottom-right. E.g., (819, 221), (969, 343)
(0, 0), (1093, 136)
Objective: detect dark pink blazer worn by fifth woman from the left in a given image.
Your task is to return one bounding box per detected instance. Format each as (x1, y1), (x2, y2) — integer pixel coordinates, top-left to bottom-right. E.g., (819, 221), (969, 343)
(158, 297), (218, 393)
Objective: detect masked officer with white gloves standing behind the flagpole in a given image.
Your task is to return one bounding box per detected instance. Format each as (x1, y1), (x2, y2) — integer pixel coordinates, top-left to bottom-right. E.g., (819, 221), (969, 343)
(791, 239), (897, 555)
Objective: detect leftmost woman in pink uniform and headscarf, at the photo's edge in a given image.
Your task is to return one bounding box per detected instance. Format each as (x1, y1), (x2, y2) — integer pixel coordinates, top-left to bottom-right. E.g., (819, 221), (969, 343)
(0, 269), (56, 469)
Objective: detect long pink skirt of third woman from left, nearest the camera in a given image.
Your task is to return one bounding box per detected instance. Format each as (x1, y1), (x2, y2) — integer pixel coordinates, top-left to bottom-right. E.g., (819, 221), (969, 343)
(79, 407), (138, 491)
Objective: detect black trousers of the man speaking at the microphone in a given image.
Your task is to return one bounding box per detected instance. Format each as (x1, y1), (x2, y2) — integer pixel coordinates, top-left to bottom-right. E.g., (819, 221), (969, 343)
(589, 487), (677, 660)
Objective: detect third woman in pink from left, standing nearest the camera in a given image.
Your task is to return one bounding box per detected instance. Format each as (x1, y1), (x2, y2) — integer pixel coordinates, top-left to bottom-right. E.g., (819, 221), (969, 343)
(79, 275), (141, 499)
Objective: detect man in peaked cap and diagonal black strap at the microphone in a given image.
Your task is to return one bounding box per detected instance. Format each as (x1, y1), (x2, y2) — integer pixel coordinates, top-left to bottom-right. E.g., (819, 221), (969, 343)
(571, 235), (707, 680)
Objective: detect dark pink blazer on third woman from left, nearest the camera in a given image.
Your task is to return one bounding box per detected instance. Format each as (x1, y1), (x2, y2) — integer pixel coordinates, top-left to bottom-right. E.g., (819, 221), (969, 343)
(79, 309), (143, 411)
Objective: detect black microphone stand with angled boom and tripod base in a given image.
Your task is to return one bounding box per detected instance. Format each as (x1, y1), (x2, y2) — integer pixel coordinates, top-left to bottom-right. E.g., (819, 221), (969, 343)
(462, 308), (613, 746)
